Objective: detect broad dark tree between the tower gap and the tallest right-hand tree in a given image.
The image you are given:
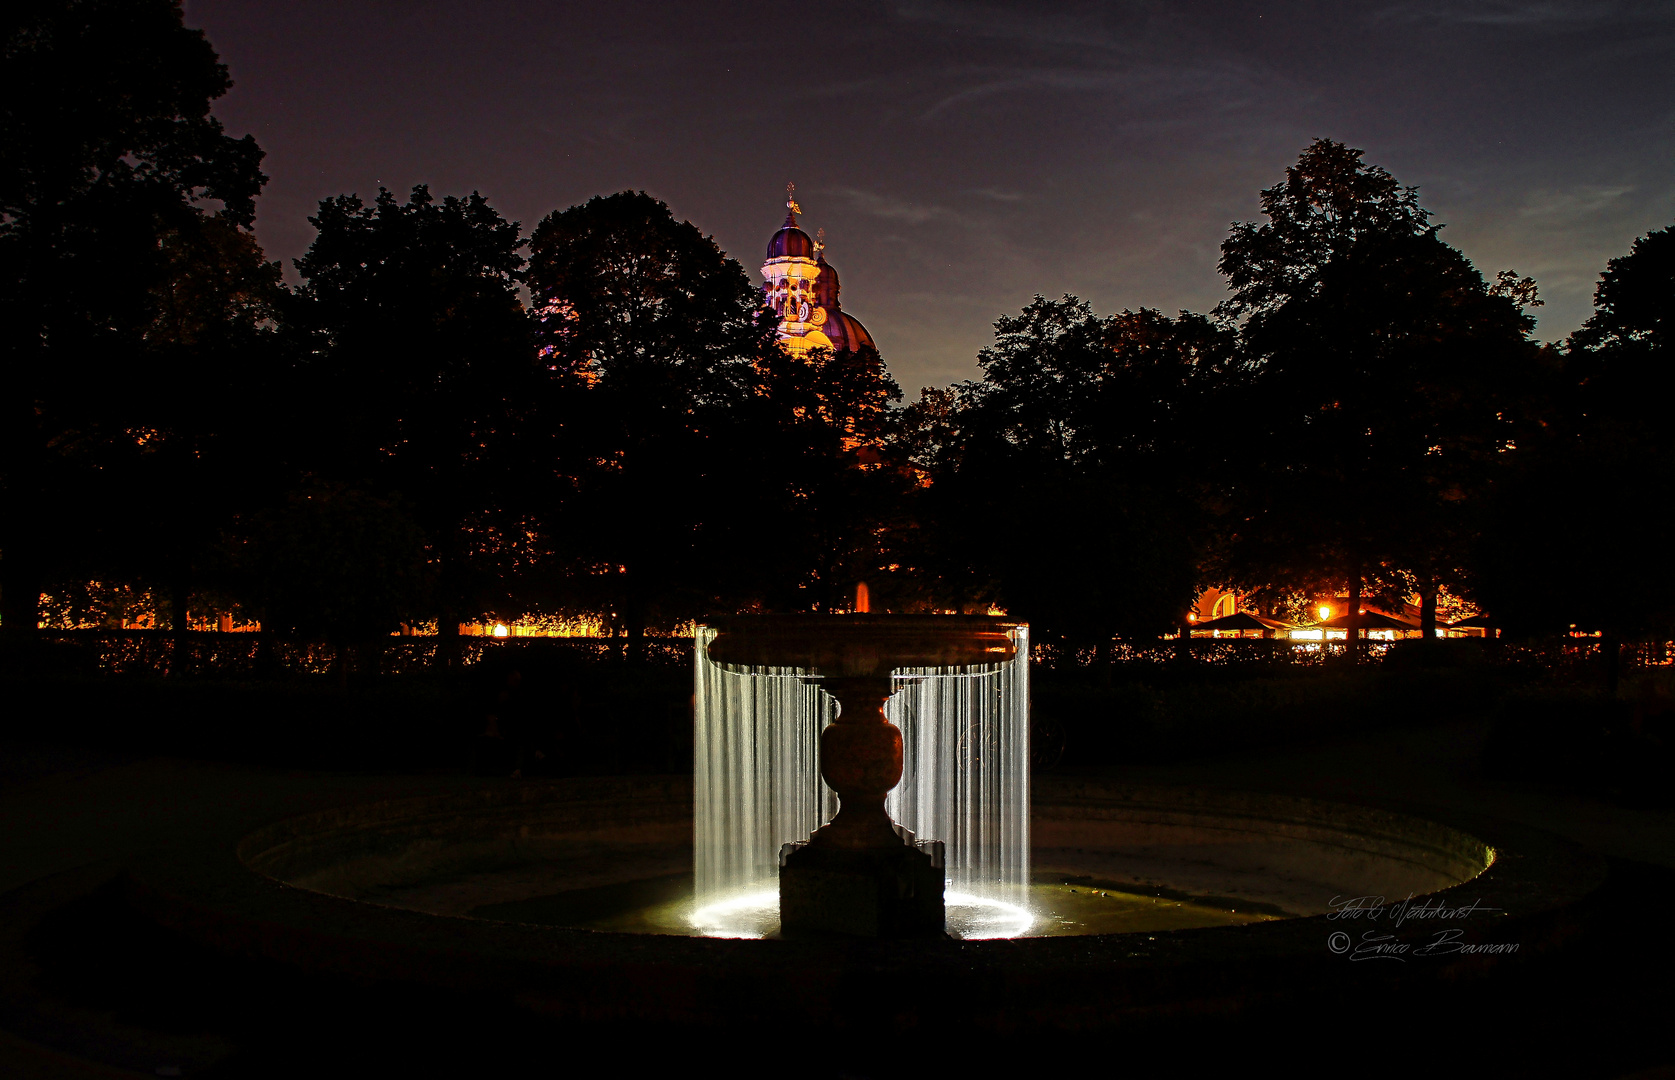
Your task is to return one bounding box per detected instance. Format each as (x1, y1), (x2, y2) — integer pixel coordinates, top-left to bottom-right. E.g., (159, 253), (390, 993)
(911, 296), (1233, 655)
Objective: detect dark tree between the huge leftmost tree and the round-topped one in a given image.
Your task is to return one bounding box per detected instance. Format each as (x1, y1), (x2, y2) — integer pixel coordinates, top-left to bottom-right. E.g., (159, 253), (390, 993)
(296, 186), (532, 656)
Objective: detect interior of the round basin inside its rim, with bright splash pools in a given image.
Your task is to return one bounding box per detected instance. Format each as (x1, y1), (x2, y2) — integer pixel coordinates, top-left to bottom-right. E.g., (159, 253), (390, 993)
(240, 782), (1494, 939)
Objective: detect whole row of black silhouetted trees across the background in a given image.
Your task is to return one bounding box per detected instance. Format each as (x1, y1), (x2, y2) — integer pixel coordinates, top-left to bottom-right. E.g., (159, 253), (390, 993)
(0, 0), (1675, 655)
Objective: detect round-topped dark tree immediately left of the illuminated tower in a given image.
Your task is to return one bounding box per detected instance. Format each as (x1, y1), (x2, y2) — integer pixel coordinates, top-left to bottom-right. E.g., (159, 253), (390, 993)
(529, 191), (774, 648)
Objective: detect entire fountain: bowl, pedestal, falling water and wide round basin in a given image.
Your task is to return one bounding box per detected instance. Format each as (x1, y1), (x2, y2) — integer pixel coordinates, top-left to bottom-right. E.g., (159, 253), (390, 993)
(88, 615), (1581, 1045)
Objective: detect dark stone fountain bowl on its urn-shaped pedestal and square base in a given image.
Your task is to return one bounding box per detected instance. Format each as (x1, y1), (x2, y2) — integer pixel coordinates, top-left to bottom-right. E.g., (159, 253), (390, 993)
(707, 615), (1015, 938)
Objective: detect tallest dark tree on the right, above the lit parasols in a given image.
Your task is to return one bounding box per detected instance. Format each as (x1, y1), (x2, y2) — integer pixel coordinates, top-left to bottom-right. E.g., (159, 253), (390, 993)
(1223, 141), (1534, 653)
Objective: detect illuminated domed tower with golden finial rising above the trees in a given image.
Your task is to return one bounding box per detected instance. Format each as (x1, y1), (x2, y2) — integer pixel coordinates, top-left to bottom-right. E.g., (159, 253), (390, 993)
(762, 184), (876, 357)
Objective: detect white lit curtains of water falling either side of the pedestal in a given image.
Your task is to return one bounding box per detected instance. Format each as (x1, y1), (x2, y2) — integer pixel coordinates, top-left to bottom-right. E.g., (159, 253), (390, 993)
(693, 626), (1030, 910)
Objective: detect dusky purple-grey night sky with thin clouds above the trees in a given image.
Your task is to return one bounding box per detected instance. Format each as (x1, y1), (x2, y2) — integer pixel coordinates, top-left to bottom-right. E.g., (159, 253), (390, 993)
(186, 0), (1675, 395)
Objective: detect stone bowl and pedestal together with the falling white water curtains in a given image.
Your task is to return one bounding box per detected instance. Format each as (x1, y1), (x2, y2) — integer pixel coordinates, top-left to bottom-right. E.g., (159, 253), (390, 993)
(693, 615), (1028, 938)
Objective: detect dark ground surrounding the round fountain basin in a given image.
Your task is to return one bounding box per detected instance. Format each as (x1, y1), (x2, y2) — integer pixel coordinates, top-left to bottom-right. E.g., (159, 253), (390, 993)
(0, 653), (1675, 1077)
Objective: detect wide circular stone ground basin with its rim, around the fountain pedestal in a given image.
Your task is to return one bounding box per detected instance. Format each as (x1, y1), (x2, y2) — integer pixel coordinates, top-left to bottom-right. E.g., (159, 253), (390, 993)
(114, 779), (1605, 1035)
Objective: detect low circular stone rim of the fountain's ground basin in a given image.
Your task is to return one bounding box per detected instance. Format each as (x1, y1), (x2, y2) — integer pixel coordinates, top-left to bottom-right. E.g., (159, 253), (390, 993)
(108, 777), (1606, 1033)
